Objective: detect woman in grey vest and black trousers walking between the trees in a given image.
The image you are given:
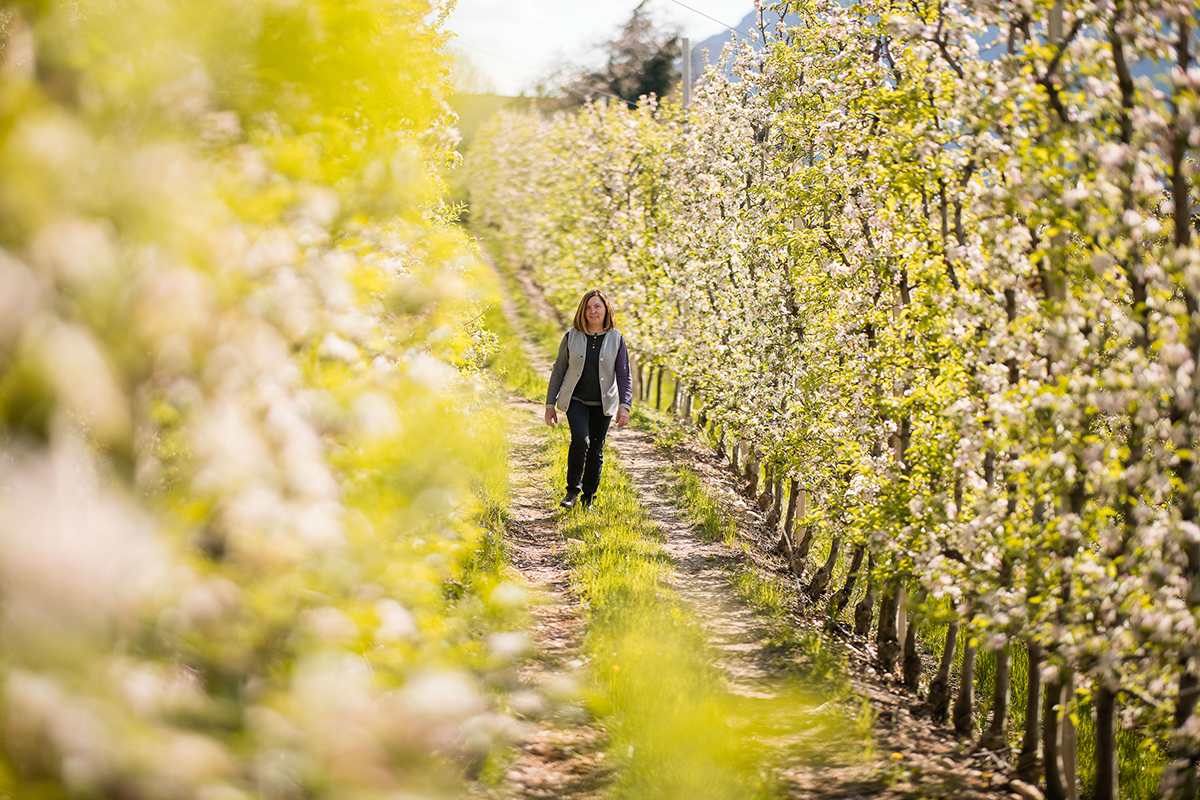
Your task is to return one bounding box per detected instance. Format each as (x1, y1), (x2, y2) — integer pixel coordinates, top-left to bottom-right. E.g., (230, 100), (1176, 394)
(546, 289), (634, 509)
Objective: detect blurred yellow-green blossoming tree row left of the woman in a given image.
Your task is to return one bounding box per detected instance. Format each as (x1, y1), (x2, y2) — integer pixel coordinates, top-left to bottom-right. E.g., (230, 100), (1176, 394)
(0, 0), (523, 800)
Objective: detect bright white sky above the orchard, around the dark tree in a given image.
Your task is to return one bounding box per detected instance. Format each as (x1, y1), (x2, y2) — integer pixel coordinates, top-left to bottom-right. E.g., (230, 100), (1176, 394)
(449, 0), (754, 95)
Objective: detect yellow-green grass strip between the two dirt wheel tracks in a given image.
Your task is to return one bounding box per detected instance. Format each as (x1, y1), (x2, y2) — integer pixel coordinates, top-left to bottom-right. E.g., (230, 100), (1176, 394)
(548, 426), (863, 799)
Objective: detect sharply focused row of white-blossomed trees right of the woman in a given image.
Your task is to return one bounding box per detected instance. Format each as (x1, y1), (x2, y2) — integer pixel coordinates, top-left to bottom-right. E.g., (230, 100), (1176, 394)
(468, 0), (1200, 798)
